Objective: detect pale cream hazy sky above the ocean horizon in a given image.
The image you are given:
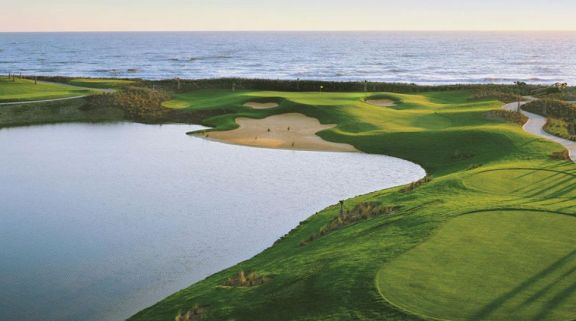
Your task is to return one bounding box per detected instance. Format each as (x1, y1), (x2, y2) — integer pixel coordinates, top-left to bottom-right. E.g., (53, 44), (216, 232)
(0, 0), (576, 31)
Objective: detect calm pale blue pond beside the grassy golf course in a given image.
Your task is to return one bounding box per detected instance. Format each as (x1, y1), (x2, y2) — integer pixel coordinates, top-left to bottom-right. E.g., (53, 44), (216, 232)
(0, 124), (424, 321)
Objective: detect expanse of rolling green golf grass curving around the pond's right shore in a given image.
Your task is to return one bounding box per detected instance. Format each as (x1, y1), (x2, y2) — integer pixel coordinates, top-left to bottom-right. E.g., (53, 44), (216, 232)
(0, 78), (576, 321)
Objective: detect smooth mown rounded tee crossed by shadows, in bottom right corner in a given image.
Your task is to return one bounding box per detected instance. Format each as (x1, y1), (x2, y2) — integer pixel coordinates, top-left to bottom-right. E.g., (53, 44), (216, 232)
(378, 211), (576, 321)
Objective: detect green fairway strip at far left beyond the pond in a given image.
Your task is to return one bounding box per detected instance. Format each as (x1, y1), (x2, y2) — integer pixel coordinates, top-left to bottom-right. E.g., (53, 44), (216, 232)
(0, 77), (97, 103)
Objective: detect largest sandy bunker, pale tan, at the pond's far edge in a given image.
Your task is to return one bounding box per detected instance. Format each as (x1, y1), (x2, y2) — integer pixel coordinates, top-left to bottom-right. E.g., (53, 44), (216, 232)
(197, 113), (358, 152)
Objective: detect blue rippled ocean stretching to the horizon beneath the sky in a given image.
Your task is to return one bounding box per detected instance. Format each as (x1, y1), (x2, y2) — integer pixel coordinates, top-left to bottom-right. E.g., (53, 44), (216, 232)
(0, 32), (576, 84)
